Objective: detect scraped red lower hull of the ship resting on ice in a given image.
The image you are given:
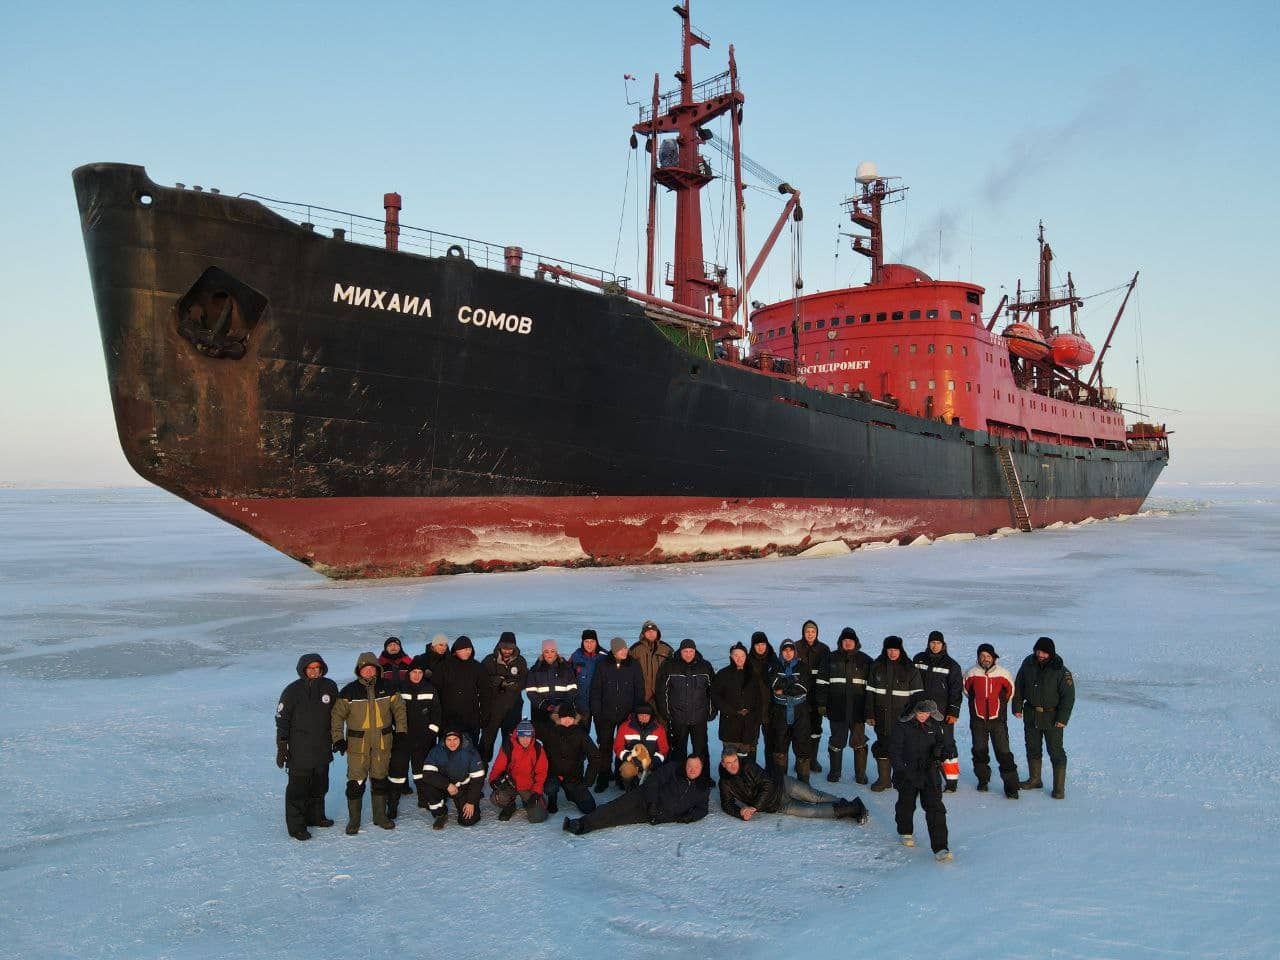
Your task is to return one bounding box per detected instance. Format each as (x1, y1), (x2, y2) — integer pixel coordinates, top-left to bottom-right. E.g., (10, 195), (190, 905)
(196, 497), (1142, 579)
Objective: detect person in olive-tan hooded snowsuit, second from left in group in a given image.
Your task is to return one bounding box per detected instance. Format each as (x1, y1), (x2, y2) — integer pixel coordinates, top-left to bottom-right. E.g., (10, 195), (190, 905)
(329, 653), (408, 836)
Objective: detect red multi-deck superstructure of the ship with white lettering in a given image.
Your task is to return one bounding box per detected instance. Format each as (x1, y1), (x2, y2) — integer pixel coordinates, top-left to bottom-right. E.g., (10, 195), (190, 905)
(750, 163), (1137, 449)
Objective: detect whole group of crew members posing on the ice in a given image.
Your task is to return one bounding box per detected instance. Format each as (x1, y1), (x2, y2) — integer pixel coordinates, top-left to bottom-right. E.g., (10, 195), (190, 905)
(275, 621), (1075, 861)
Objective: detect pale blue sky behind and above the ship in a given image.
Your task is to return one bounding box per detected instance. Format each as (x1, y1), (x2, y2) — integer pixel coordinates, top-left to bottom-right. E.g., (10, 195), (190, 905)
(0, 0), (1280, 483)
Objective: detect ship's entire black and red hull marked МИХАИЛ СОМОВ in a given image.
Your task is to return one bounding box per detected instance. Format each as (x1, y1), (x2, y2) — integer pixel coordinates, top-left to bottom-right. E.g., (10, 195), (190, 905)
(74, 164), (1167, 576)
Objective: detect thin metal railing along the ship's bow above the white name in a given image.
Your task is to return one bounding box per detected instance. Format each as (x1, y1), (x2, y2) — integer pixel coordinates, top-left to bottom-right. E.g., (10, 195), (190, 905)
(239, 193), (630, 287)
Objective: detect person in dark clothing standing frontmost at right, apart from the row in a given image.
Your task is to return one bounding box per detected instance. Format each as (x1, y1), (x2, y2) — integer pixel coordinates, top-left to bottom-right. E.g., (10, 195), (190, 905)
(888, 700), (951, 863)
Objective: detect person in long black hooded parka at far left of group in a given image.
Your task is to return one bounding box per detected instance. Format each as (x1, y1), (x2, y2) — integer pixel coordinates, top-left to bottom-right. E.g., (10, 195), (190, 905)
(275, 653), (338, 840)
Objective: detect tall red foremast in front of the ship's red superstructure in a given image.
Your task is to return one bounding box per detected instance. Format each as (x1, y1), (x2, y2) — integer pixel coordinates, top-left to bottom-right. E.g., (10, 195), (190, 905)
(634, 0), (745, 316)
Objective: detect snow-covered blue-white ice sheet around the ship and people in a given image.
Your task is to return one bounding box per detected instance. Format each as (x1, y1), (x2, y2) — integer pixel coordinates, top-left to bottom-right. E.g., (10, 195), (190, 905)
(0, 485), (1280, 960)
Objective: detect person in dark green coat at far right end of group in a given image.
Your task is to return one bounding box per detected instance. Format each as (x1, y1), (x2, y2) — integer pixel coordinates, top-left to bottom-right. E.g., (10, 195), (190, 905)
(1010, 636), (1075, 800)
